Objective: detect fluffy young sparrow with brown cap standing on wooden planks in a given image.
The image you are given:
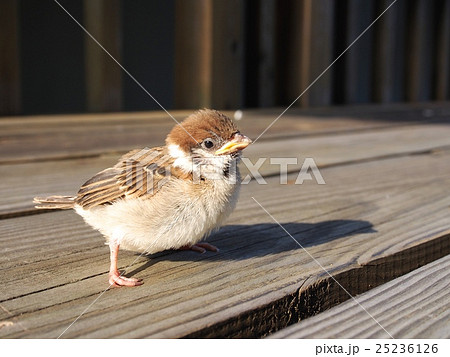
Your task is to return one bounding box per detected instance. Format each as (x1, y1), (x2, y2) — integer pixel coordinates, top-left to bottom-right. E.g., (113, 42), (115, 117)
(34, 109), (251, 286)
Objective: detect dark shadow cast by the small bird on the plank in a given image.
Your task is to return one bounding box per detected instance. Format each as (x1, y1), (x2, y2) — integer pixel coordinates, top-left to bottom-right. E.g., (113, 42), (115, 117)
(127, 220), (376, 276)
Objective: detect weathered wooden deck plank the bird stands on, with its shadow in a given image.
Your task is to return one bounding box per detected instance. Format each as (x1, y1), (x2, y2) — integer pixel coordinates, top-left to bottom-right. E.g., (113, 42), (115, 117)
(0, 153), (450, 338)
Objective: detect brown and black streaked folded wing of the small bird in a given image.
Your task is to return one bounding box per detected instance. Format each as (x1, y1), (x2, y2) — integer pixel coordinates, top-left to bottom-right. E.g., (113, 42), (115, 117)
(75, 147), (188, 208)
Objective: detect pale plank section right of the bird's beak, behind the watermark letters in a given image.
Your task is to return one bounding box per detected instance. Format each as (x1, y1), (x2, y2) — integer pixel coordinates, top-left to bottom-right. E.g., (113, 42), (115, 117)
(245, 125), (450, 176)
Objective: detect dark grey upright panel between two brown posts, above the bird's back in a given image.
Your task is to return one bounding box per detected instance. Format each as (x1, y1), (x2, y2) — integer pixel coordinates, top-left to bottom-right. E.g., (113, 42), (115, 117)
(120, 0), (176, 111)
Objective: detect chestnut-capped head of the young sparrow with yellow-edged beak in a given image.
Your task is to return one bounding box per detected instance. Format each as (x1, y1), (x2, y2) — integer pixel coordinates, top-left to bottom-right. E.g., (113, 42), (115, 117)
(166, 109), (252, 179)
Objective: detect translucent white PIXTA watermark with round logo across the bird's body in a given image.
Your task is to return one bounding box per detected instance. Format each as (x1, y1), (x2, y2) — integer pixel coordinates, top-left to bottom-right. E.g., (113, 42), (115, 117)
(122, 148), (325, 194)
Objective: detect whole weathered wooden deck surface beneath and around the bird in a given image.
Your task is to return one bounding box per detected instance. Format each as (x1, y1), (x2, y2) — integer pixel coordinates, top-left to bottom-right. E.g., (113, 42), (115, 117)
(0, 103), (450, 338)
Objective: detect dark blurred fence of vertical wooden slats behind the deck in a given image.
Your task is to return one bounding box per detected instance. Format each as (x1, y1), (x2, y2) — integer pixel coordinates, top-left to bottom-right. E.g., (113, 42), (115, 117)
(0, 0), (450, 115)
